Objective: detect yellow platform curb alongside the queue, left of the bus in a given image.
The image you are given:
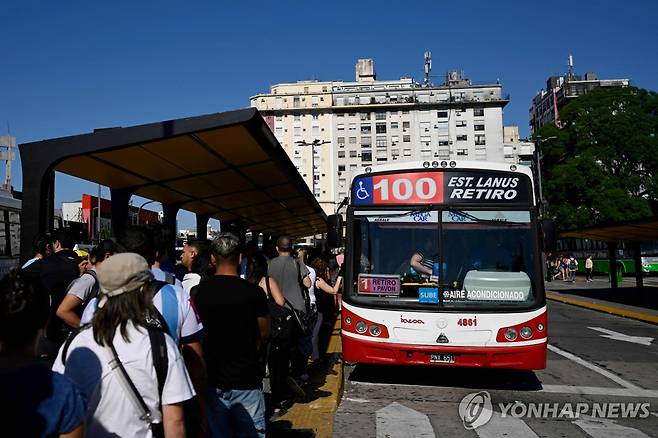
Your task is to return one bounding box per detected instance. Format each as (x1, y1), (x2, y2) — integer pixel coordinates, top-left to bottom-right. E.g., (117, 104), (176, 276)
(277, 315), (343, 437)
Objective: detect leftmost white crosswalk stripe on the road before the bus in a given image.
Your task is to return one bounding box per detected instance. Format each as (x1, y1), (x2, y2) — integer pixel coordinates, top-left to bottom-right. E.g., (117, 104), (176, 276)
(377, 402), (435, 438)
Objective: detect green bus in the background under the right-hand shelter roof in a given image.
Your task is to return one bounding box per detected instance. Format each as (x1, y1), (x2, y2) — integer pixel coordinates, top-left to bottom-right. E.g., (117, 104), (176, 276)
(555, 238), (658, 276)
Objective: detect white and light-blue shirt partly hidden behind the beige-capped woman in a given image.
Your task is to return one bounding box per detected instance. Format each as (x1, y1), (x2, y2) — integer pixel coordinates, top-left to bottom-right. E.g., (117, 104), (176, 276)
(80, 269), (203, 344)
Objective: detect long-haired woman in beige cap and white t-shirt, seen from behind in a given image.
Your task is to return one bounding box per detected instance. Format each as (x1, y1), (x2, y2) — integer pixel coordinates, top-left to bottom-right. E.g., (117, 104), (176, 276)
(53, 253), (195, 438)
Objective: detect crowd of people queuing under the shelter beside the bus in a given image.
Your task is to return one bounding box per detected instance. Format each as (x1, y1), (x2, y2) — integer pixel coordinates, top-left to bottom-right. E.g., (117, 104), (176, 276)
(0, 224), (343, 437)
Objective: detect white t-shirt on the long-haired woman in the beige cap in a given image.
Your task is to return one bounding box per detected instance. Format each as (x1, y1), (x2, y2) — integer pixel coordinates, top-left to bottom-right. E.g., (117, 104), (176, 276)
(53, 322), (195, 437)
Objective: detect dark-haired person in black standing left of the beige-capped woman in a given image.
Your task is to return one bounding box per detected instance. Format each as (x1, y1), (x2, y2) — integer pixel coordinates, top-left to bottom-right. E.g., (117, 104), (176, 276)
(24, 228), (80, 359)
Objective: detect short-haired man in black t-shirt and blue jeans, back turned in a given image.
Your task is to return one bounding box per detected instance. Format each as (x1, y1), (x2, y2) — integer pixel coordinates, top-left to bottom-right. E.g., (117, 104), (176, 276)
(193, 232), (269, 437)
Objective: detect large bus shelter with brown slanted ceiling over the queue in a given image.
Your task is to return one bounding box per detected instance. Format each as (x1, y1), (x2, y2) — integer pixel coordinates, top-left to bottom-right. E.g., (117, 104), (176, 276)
(19, 108), (327, 260)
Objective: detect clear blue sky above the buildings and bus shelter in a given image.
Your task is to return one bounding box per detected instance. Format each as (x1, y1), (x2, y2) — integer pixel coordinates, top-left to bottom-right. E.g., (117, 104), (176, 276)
(0, 0), (658, 227)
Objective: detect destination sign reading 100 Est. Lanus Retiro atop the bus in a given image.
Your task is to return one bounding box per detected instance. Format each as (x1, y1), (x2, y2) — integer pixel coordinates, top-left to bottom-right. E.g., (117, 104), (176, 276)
(352, 171), (531, 205)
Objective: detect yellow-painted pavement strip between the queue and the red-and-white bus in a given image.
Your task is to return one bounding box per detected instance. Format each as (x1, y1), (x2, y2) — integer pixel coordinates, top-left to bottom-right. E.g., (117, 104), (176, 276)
(267, 315), (343, 438)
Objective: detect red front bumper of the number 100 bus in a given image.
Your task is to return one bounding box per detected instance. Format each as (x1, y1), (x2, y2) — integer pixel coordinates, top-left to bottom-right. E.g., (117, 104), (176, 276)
(342, 335), (547, 370)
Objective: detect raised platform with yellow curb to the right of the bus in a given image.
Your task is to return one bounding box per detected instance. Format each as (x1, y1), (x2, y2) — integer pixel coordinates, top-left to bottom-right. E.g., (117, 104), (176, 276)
(545, 277), (658, 324)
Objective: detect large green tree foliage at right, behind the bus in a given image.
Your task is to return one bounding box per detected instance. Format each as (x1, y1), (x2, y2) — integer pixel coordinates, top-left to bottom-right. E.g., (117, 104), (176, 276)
(536, 87), (658, 230)
